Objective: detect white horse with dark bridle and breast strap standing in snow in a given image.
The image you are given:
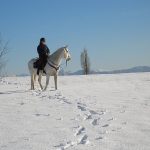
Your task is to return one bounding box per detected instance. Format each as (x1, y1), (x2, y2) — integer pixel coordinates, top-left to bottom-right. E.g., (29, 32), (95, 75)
(28, 46), (71, 90)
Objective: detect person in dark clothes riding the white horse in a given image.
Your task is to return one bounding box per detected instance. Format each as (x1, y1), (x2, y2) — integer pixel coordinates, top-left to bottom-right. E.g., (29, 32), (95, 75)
(37, 38), (50, 74)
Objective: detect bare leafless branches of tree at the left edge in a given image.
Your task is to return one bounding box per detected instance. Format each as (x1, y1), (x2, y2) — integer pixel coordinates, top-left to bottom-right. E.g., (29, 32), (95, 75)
(0, 36), (8, 74)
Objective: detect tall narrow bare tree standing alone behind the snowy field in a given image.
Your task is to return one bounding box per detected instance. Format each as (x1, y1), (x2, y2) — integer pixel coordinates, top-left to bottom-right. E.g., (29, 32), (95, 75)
(81, 49), (90, 75)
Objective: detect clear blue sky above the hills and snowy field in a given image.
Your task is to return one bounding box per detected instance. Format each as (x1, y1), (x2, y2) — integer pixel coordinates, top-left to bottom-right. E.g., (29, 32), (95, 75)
(0, 0), (150, 74)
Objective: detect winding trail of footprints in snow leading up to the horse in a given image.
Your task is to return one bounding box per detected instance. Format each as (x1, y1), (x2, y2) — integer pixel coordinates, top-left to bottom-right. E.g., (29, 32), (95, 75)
(32, 91), (113, 150)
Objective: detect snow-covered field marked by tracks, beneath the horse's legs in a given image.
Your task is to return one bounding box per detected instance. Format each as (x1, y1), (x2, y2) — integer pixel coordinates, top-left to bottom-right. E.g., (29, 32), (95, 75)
(0, 73), (150, 150)
